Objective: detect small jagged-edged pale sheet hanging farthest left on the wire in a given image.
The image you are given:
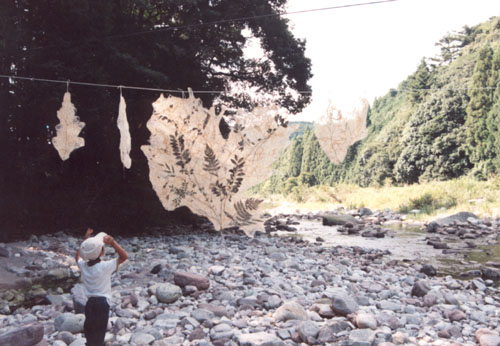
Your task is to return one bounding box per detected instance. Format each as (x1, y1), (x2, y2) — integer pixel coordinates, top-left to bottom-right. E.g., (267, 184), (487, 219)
(52, 92), (85, 161)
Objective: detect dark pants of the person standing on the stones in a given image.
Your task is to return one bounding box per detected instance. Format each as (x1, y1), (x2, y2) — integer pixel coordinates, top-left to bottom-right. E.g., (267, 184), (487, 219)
(83, 297), (109, 346)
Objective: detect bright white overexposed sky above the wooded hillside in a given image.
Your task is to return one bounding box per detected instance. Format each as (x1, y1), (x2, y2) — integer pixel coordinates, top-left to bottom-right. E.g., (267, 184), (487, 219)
(286, 0), (500, 121)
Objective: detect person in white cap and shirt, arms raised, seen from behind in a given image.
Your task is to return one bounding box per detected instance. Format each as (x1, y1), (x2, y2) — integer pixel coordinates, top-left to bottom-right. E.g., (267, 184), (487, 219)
(75, 228), (128, 346)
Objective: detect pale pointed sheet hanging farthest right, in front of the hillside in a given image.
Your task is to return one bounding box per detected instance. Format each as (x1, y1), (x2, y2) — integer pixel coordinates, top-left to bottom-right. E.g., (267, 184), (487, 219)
(314, 99), (368, 163)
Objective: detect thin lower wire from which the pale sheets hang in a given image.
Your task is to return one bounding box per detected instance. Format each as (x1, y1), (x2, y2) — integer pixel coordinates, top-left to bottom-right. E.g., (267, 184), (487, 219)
(0, 74), (500, 95)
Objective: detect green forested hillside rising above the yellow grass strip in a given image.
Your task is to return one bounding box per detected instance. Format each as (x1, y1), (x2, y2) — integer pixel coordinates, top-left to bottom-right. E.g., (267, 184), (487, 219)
(260, 17), (500, 194)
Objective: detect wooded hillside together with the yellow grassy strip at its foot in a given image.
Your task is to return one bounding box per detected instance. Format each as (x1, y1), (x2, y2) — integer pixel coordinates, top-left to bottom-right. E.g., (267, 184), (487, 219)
(253, 17), (500, 219)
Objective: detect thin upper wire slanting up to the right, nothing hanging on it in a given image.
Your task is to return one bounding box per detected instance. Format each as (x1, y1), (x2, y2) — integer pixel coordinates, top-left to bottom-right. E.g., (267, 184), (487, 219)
(0, 0), (399, 52)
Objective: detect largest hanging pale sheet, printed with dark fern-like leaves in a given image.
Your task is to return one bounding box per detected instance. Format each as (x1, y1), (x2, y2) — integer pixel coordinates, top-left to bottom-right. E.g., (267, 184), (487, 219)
(142, 92), (289, 235)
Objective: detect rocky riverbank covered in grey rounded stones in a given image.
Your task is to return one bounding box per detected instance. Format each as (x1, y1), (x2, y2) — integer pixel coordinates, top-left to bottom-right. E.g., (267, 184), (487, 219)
(0, 215), (500, 346)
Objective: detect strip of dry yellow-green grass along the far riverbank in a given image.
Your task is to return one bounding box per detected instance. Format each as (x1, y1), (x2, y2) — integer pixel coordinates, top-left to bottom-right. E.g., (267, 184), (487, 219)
(260, 177), (500, 220)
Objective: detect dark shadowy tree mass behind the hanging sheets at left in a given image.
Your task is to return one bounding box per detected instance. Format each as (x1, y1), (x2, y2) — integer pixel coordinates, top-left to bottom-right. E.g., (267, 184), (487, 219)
(0, 0), (311, 241)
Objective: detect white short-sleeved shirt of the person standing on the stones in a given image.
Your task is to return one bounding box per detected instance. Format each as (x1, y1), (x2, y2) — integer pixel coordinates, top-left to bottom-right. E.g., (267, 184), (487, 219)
(78, 258), (118, 304)
